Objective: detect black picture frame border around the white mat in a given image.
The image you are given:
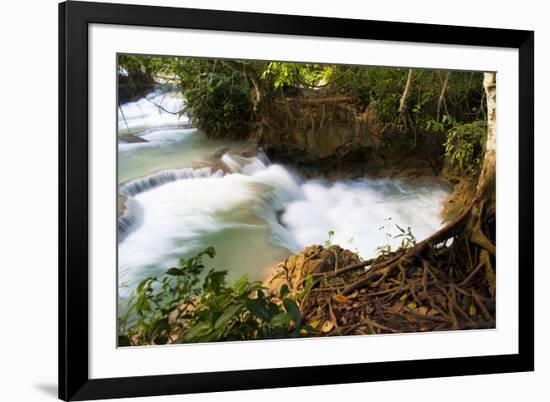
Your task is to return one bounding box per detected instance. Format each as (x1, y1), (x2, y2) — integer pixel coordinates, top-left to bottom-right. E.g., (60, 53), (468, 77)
(59, 1), (534, 400)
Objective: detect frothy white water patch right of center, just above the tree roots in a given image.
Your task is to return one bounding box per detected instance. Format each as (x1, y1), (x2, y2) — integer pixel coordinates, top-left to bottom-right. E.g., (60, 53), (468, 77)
(281, 179), (448, 258)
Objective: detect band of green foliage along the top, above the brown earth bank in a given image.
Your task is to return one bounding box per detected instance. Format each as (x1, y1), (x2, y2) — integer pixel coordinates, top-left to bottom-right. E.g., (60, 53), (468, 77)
(119, 55), (486, 165)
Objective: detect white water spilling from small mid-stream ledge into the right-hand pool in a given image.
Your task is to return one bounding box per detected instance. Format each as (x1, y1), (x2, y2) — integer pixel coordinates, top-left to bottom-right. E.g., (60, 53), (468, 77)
(222, 154), (449, 257)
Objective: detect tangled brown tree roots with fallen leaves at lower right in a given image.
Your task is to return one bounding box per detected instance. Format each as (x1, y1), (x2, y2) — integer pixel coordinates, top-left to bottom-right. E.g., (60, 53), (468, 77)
(301, 202), (496, 335)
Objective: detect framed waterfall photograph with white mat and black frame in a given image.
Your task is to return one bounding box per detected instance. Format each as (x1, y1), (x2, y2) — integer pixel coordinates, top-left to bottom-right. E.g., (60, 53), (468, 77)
(59, 1), (534, 400)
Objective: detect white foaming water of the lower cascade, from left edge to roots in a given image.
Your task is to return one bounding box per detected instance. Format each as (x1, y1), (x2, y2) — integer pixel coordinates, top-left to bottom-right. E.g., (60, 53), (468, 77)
(119, 154), (448, 292)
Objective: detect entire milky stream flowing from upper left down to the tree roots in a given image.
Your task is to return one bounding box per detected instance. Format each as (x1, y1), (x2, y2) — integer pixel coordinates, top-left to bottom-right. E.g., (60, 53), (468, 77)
(118, 93), (449, 295)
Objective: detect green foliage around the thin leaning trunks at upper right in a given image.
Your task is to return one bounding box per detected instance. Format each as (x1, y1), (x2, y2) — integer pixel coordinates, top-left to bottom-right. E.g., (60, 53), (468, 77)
(335, 67), (484, 134)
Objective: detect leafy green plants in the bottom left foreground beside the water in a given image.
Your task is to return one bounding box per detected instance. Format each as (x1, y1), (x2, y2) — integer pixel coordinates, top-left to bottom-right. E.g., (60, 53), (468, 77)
(119, 247), (313, 346)
